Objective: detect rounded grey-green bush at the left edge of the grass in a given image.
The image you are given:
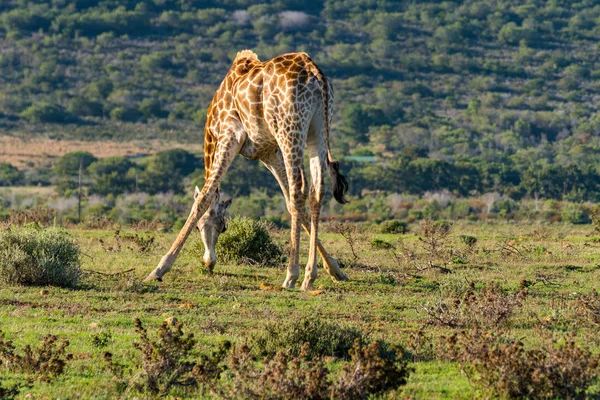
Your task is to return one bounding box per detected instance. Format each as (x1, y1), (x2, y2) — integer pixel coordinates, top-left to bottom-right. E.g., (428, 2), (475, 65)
(0, 225), (81, 287)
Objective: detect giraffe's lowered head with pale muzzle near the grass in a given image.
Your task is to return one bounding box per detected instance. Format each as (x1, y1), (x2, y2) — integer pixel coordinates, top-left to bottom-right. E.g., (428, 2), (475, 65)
(194, 186), (232, 272)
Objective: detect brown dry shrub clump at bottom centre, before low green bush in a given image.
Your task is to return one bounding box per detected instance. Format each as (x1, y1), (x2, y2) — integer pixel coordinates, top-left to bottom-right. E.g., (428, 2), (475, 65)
(219, 340), (412, 400)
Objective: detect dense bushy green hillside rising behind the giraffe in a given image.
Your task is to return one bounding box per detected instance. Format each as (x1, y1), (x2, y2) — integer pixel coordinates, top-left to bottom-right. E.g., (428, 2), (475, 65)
(0, 0), (600, 206)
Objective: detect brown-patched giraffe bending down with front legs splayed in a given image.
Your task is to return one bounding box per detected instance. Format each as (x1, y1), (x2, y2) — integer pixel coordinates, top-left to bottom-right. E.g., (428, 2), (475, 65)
(145, 50), (348, 290)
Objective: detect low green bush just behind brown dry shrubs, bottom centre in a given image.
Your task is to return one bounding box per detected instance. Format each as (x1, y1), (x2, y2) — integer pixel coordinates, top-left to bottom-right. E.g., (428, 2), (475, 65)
(249, 319), (364, 358)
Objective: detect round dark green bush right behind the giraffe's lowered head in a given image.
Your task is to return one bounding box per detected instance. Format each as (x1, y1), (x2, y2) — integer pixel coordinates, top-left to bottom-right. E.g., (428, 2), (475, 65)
(192, 218), (283, 266)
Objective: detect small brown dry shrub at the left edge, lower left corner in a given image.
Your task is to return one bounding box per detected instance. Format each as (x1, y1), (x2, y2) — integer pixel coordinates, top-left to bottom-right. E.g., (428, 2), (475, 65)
(0, 332), (72, 382)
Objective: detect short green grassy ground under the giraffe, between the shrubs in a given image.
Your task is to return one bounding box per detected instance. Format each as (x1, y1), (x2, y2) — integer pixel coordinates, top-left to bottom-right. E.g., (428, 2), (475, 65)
(0, 222), (600, 399)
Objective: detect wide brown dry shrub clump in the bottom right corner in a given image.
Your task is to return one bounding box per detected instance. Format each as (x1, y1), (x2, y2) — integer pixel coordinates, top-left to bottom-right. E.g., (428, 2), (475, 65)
(444, 329), (600, 399)
